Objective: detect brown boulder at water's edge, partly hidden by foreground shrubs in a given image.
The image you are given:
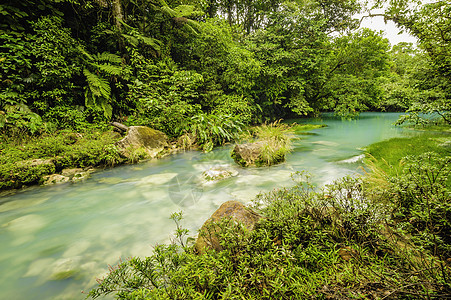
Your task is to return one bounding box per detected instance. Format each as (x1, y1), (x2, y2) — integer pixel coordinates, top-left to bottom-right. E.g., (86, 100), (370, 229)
(195, 201), (262, 254)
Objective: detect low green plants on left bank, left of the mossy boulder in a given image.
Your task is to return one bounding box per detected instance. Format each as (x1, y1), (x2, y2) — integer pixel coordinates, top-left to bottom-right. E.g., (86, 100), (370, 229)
(0, 131), (125, 190)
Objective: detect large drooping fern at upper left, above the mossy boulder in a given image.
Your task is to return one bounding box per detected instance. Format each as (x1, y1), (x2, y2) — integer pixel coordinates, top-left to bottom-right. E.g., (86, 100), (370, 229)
(79, 47), (123, 119)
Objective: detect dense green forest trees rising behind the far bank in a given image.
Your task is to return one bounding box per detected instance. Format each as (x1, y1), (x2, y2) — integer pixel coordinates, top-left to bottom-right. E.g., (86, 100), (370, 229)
(0, 0), (451, 140)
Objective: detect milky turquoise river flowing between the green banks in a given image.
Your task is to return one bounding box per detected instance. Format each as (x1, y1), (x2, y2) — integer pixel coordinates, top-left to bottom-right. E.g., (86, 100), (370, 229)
(0, 113), (416, 300)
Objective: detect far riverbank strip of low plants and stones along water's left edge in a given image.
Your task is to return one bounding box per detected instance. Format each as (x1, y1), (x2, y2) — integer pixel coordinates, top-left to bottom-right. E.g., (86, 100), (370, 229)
(0, 124), (323, 196)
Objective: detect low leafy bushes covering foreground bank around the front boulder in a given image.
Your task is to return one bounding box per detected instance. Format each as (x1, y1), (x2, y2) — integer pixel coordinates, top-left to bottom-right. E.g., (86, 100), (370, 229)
(89, 170), (451, 299)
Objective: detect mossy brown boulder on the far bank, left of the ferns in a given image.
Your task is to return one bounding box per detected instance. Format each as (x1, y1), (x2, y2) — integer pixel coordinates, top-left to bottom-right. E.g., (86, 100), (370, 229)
(116, 126), (168, 158)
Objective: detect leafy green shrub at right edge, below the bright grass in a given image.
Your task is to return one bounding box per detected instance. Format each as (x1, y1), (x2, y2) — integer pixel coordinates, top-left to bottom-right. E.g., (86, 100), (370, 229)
(388, 152), (451, 258)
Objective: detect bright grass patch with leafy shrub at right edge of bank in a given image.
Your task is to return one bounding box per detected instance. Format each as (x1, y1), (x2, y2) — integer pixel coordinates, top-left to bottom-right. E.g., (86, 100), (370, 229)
(366, 133), (451, 259)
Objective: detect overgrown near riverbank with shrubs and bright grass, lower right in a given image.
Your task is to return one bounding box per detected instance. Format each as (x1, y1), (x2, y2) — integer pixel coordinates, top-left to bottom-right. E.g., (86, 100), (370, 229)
(90, 125), (451, 299)
